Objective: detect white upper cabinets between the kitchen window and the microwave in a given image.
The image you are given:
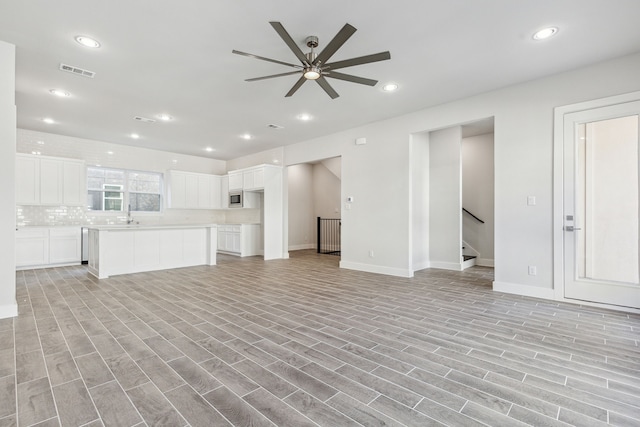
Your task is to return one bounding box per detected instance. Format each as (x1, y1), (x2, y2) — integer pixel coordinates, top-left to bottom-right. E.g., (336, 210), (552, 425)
(165, 170), (221, 209)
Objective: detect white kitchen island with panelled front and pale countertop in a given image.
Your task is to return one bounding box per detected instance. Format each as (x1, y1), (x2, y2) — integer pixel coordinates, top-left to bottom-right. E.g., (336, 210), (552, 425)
(88, 224), (217, 279)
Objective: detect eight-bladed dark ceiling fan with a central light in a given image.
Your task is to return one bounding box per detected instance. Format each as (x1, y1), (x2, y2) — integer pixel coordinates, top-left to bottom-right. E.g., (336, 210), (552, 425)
(232, 22), (391, 99)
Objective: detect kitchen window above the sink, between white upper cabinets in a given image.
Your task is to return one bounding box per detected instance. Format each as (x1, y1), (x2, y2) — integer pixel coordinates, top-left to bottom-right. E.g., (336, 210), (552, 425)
(87, 167), (162, 212)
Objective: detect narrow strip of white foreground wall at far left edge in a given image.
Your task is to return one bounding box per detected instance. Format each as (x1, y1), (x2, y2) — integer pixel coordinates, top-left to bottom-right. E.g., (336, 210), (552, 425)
(0, 41), (18, 319)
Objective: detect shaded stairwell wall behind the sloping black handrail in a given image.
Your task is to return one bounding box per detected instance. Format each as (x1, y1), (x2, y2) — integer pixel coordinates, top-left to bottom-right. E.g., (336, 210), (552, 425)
(462, 133), (494, 266)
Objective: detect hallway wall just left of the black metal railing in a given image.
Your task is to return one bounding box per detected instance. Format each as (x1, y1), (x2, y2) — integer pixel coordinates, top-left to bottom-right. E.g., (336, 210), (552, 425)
(287, 163), (316, 250)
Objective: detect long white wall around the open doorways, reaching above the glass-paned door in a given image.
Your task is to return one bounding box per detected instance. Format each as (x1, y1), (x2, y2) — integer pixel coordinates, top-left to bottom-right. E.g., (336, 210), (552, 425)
(285, 54), (640, 298)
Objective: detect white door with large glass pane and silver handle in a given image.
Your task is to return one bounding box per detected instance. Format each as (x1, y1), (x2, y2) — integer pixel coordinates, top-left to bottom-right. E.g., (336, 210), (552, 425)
(564, 101), (640, 308)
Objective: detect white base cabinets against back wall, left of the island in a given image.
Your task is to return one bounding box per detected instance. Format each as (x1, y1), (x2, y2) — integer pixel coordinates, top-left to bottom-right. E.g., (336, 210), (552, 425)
(15, 226), (82, 269)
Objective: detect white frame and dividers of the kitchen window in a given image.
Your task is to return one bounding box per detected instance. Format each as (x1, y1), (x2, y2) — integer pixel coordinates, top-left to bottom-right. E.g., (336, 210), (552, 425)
(85, 166), (165, 215)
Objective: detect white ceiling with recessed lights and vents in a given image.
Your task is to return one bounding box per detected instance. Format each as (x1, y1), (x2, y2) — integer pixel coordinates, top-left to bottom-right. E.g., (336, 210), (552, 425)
(0, 0), (640, 160)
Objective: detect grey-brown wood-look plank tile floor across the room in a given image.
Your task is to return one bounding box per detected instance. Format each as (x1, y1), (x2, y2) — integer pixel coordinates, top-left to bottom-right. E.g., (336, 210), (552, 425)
(0, 251), (640, 427)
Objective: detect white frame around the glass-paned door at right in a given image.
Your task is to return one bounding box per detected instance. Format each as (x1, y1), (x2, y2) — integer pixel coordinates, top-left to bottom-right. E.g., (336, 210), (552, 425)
(553, 91), (640, 313)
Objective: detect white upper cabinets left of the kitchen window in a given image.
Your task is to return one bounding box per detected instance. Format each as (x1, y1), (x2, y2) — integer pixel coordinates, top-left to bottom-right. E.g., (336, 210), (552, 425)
(16, 154), (86, 206)
